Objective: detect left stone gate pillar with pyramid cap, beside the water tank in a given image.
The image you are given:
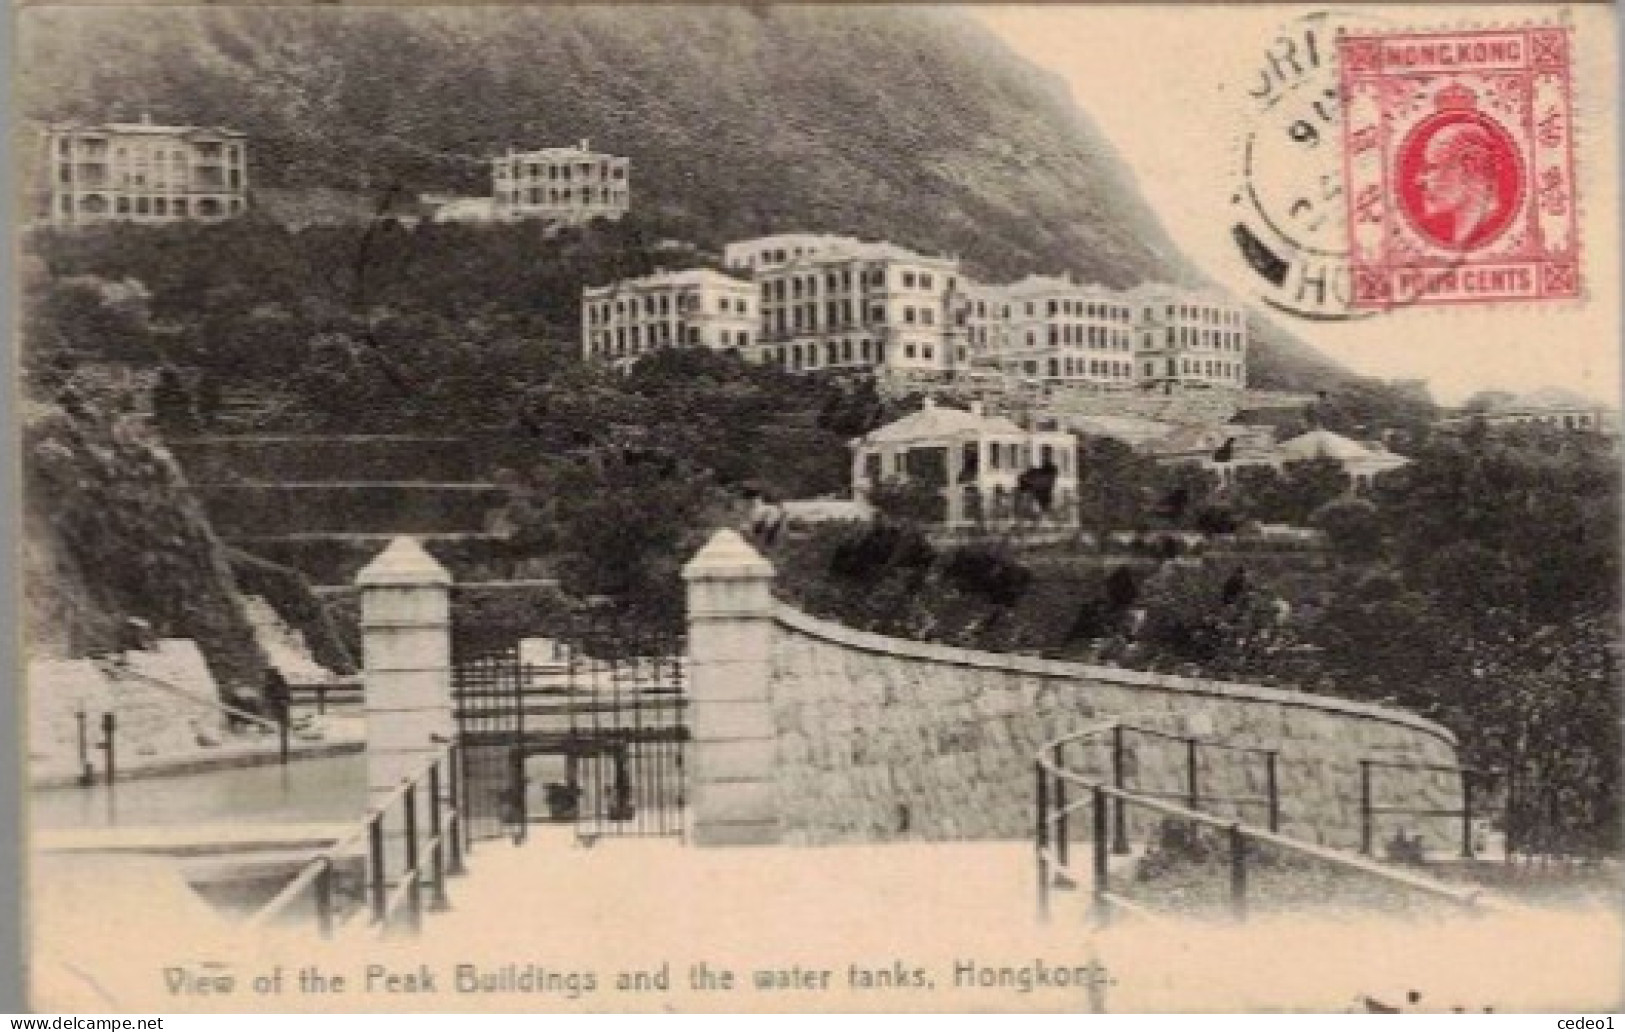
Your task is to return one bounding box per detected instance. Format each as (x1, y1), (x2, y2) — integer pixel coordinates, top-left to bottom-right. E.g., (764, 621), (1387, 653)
(356, 538), (455, 806)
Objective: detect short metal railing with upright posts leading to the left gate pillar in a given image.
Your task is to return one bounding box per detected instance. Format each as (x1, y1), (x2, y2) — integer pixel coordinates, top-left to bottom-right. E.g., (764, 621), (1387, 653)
(249, 744), (468, 938)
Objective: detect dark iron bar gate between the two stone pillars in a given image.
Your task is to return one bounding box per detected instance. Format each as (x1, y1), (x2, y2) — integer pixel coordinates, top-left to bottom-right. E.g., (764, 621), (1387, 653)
(452, 585), (689, 840)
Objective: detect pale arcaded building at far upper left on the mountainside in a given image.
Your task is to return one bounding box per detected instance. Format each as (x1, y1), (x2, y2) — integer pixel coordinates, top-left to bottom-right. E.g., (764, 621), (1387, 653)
(44, 117), (249, 226)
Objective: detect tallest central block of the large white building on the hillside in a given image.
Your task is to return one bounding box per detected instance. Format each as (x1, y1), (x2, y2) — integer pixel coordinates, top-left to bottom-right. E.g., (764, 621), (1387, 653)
(752, 242), (969, 374)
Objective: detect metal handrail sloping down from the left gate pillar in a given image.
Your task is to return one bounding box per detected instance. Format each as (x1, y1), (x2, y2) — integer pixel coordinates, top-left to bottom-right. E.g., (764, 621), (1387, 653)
(247, 738), (466, 938)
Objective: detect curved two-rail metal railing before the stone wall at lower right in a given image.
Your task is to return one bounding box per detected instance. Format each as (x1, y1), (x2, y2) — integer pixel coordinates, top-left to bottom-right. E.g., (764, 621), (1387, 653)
(1034, 720), (1495, 923)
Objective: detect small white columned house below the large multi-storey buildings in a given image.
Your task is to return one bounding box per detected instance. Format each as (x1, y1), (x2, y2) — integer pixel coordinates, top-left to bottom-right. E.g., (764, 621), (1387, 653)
(852, 397), (1077, 527)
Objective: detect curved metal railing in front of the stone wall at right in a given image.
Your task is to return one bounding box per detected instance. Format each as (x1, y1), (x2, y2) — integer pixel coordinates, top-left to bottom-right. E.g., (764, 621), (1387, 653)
(1034, 720), (1498, 921)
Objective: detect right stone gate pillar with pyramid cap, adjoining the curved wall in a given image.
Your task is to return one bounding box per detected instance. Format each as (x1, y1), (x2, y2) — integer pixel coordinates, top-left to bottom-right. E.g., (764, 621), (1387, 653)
(683, 530), (780, 845)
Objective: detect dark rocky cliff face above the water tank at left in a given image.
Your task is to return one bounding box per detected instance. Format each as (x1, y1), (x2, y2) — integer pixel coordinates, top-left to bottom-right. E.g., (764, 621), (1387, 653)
(23, 403), (265, 691)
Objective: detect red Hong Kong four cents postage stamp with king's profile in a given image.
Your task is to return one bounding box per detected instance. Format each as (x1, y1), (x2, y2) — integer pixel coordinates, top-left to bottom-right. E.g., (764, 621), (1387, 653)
(1339, 28), (1581, 309)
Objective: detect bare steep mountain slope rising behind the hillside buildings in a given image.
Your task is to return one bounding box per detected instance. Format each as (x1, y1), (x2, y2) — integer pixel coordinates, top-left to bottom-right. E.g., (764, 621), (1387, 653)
(18, 5), (1346, 387)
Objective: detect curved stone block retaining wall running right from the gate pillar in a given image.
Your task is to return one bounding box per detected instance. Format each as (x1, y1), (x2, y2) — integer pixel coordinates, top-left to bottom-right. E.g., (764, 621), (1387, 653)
(769, 605), (1461, 850)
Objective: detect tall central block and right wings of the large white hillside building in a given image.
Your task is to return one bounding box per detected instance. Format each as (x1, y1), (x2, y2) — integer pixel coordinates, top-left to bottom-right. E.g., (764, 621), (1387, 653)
(708, 232), (1246, 393)
